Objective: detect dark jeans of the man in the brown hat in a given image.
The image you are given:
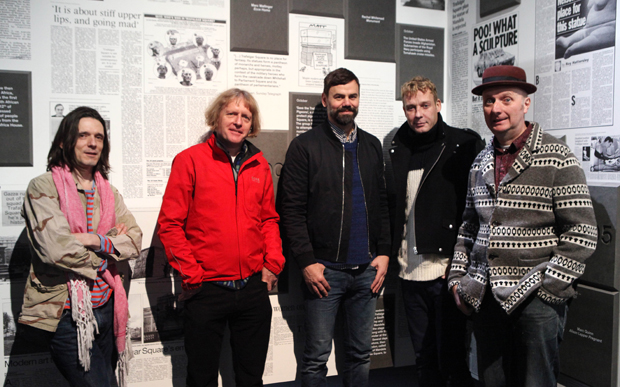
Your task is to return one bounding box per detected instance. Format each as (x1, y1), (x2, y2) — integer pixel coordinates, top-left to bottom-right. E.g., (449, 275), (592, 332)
(473, 288), (568, 387)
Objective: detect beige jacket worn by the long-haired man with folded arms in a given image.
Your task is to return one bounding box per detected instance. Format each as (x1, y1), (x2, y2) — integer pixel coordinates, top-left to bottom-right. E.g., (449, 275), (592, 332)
(19, 172), (142, 332)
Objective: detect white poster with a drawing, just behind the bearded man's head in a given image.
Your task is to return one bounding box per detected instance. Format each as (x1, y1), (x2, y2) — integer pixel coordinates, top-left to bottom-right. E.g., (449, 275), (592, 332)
(297, 22), (338, 87)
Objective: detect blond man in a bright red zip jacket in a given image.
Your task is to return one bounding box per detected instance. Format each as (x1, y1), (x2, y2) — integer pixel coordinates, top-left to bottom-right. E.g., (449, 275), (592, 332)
(158, 89), (284, 386)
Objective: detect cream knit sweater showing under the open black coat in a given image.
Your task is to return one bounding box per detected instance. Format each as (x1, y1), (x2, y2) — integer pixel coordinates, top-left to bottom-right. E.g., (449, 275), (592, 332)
(398, 169), (450, 281)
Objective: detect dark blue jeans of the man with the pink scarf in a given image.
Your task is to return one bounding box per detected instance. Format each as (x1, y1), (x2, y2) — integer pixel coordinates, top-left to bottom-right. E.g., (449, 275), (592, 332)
(50, 296), (118, 387)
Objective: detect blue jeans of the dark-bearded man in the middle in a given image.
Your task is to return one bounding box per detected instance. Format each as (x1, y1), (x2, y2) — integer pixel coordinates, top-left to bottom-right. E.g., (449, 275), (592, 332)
(301, 265), (377, 387)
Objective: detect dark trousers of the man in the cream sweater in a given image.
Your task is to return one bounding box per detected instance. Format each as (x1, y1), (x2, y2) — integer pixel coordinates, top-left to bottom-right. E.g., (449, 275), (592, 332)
(401, 278), (473, 387)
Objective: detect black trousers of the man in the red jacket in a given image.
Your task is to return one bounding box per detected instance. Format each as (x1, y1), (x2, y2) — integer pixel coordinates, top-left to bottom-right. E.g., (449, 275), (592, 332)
(184, 274), (272, 387)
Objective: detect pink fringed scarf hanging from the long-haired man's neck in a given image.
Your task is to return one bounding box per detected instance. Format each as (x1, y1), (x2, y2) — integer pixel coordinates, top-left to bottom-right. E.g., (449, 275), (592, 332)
(52, 166), (133, 386)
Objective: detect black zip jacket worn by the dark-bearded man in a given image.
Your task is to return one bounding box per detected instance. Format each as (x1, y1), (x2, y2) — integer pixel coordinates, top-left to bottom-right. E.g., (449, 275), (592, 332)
(278, 121), (391, 268)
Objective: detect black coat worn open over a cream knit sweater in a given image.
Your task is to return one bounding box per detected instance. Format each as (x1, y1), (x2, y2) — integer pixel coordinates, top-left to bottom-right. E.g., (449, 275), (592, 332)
(389, 113), (484, 257)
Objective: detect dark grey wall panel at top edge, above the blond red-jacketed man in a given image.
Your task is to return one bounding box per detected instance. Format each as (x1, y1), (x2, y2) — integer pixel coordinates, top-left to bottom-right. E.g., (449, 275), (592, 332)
(230, 0), (288, 55)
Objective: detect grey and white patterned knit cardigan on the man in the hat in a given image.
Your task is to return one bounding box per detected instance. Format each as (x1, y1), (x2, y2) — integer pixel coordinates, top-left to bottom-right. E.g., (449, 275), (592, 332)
(448, 122), (597, 313)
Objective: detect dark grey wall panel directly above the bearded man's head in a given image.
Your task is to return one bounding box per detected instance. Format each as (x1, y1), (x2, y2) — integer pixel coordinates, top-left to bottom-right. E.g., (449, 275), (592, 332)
(344, 0), (396, 62)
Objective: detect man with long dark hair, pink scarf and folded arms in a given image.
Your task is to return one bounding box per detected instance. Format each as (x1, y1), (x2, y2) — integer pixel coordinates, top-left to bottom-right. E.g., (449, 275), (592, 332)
(19, 107), (142, 387)
